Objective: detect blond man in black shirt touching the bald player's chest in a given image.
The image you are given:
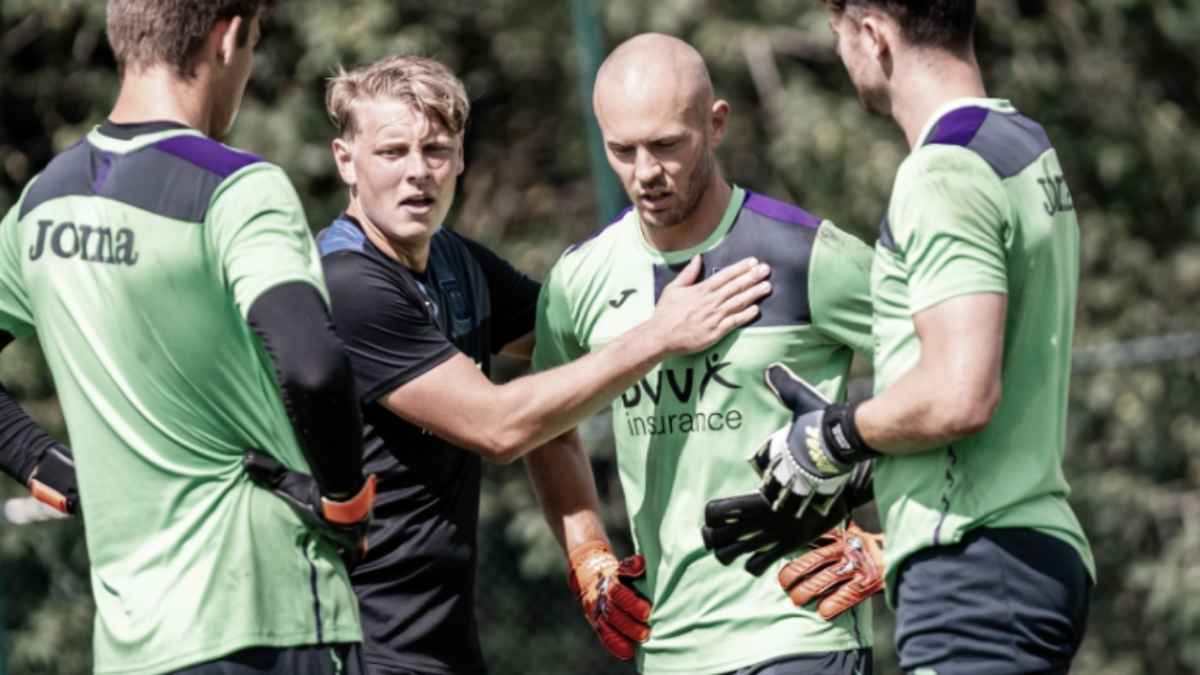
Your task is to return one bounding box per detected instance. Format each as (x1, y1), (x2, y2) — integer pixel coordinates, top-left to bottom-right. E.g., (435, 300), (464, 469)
(317, 56), (769, 675)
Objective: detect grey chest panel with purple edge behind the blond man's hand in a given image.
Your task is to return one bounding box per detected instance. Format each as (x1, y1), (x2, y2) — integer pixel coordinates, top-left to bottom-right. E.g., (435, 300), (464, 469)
(654, 191), (821, 328)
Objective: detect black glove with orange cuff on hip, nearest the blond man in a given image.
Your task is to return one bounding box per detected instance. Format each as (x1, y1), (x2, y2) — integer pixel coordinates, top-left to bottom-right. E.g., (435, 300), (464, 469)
(241, 449), (376, 567)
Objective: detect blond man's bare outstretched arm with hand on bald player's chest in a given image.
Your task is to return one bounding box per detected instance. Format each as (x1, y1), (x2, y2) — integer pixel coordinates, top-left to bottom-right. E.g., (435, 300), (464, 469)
(379, 253), (770, 464)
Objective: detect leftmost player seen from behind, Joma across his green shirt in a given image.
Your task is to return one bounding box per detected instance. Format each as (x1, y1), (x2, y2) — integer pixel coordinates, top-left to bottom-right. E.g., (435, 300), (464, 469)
(0, 0), (372, 675)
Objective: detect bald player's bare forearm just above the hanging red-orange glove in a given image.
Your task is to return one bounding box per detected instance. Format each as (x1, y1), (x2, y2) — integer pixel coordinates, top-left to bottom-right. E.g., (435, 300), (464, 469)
(526, 431), (608, 554)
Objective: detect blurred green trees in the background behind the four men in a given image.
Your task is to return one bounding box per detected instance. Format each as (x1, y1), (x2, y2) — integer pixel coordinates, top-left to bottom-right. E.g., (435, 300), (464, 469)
(0, 0), (1200, 675)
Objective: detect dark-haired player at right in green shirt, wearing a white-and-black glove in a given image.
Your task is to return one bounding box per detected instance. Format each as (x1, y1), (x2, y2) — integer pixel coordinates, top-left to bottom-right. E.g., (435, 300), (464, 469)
(768, 0), (1094, 674)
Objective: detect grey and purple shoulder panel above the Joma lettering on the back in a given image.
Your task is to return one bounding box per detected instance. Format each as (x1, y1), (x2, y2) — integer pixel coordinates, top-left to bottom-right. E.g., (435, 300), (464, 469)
(19, 136), (262, 222)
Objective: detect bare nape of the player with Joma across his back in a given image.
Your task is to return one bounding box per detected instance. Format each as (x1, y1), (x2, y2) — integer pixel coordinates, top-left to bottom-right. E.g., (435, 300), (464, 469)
(108, 66), (216, 136)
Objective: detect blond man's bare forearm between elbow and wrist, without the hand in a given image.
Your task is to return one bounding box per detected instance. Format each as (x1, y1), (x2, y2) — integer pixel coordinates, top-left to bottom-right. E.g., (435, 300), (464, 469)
(493, 324), (667, 459)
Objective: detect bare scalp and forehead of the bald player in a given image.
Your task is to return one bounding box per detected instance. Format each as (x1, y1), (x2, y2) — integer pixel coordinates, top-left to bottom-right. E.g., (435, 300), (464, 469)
(592, 32), (713, 125)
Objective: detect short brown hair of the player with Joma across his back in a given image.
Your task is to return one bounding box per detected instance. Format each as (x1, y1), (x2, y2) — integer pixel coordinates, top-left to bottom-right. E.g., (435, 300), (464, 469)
(107, 0), (275, 78)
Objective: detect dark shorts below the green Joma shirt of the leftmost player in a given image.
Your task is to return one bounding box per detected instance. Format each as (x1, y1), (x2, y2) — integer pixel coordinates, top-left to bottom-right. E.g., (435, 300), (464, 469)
(174, 643), (366, 675)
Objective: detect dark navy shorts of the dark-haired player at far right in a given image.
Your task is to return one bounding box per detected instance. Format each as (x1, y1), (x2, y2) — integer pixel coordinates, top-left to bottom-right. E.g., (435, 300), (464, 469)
(896, 528), (1091, 675)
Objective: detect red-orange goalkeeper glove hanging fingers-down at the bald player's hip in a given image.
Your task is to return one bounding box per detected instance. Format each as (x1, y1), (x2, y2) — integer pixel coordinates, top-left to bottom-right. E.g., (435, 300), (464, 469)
(566, 540), (650, 661)
